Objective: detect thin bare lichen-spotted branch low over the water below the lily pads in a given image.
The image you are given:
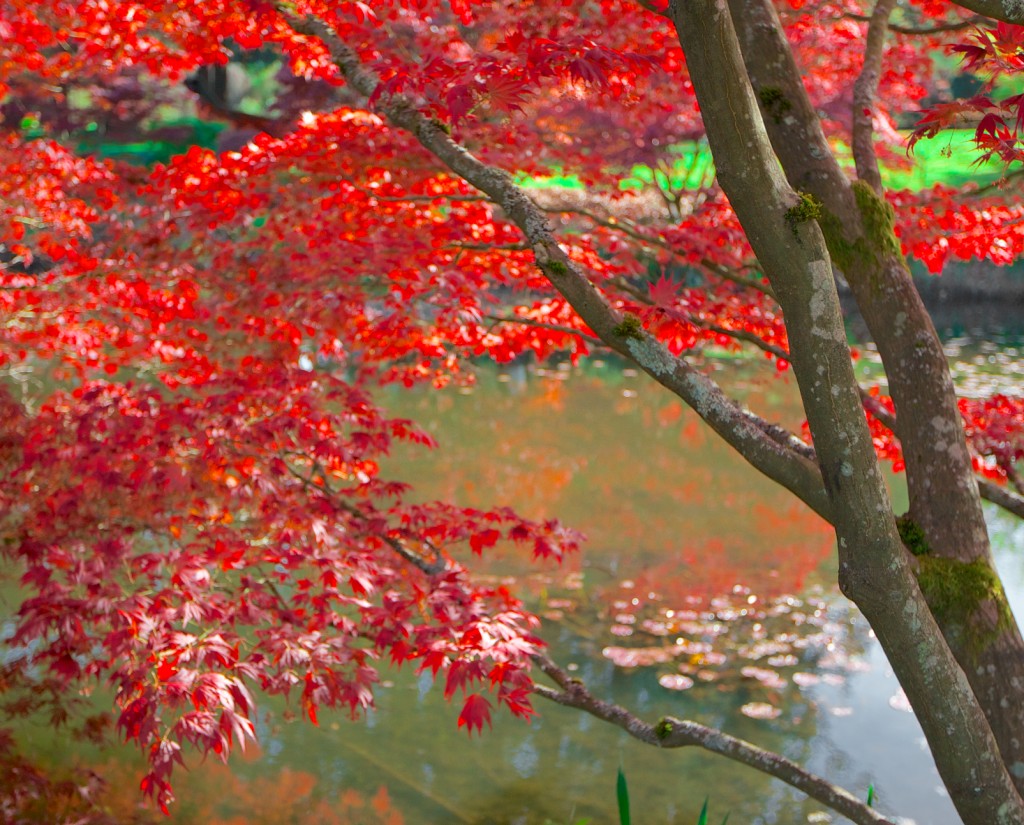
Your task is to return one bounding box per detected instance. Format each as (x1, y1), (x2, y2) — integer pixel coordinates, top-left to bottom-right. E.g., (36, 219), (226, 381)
(532, 654), (893, 825)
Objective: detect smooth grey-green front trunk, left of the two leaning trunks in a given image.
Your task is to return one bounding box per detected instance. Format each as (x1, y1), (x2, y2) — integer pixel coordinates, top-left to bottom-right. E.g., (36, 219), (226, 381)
(670, 0), (1024, 825)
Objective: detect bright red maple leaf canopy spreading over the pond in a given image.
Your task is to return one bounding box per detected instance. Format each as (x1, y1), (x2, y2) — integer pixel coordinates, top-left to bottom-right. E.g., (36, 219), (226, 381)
(0, 0), (1024, 805)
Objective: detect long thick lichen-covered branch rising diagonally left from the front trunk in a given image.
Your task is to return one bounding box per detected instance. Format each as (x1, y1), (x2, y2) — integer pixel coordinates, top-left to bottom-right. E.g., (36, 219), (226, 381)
(280, 8), (831, 520)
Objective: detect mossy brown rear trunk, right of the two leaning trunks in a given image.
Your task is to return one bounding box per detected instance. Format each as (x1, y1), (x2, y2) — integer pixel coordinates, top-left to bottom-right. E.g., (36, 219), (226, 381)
(730, 0), (1024, 792)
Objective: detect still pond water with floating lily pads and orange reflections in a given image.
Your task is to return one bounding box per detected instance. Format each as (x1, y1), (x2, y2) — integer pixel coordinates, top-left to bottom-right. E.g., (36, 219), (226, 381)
(8, 325), (1024, 825)
